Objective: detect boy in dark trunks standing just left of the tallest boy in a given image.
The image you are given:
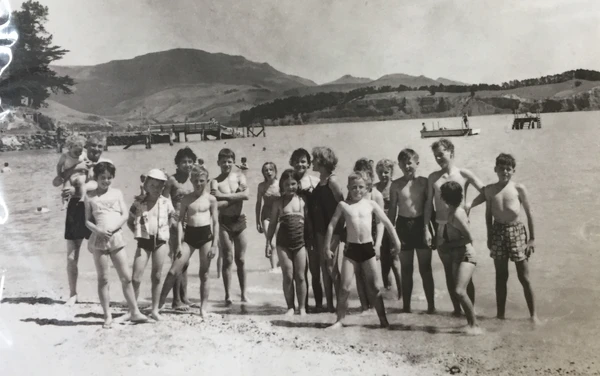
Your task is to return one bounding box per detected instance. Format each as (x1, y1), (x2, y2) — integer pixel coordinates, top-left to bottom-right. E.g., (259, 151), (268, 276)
(388, 149), (435, 313)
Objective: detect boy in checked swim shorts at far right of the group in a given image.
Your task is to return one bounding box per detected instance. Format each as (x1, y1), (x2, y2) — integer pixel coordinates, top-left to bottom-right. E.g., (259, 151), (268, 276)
(484, 153), (540, 324)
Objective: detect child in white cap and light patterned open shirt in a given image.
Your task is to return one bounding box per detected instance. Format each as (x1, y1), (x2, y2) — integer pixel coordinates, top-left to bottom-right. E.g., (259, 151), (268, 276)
(127, 169), (176, 321)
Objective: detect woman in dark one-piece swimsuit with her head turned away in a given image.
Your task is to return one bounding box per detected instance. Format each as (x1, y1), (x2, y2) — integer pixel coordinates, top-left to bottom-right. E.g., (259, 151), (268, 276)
(310, 147), (344, 312)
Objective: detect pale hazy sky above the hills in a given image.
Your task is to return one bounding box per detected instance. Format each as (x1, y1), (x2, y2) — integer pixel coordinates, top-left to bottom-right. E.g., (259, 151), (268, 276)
(4, 0), (600, 83)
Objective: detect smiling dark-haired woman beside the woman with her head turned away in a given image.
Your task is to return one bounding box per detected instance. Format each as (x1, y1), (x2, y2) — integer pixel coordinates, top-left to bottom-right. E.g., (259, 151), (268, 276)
(290, 148), (323, 312)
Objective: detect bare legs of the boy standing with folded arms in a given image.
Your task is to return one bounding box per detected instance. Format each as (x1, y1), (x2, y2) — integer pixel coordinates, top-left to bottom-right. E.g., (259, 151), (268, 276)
(219, 228), (248, 304)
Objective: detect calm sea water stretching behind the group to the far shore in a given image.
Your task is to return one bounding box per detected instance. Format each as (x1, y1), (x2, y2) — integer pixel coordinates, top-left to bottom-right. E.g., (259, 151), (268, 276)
(0, 112), (600, 370)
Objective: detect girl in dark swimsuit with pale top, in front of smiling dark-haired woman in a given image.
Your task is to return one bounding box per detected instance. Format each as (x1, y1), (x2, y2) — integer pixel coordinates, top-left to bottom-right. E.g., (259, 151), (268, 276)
(267, 169), (308, 316)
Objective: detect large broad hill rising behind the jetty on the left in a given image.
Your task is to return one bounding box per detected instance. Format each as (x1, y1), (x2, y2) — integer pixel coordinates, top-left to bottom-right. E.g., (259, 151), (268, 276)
(52, 49), (316, 117)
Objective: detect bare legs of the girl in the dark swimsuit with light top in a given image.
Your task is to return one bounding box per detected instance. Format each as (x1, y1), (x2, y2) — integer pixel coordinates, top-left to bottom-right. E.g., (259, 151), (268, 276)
(277, 247), (307, 316)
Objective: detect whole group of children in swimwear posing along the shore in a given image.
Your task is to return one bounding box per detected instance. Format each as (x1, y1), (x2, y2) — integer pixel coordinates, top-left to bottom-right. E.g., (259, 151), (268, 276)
(55, 139), (538, 334)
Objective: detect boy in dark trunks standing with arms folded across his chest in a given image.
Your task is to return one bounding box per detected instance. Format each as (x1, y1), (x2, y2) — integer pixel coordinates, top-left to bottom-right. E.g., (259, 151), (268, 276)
(210, 148), (250, 305)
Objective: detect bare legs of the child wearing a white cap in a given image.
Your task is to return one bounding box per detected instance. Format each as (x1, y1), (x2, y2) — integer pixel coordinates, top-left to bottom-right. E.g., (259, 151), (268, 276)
(132, 244), (169, 320)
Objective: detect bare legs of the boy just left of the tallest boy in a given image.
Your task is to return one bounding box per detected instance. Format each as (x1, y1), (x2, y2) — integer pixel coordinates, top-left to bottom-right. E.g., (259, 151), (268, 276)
(400, 249), (435, 313)
